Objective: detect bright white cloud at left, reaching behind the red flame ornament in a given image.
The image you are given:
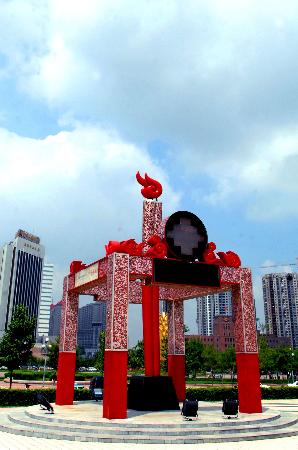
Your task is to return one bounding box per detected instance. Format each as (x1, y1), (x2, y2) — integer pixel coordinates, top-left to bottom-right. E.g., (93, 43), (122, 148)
(0, 124), (179, 302)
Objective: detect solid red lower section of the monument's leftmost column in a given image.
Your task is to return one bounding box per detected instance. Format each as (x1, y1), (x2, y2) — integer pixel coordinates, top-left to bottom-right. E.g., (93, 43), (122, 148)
(56, 352), (76, 405)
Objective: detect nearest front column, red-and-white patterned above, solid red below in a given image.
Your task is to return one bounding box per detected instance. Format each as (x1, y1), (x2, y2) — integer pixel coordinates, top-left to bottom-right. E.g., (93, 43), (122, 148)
(103, 253), (129, 419)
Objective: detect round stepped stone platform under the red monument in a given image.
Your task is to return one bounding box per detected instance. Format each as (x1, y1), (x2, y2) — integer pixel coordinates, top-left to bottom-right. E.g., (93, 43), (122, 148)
(0, 401), (298, 444)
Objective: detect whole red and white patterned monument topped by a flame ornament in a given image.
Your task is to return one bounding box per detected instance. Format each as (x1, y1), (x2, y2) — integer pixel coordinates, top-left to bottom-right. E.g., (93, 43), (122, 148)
(56, 172), (262, 419)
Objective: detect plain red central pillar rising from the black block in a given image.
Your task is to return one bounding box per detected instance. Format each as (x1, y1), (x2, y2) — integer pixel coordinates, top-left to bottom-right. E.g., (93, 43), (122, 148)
(142, 286), (160, 376)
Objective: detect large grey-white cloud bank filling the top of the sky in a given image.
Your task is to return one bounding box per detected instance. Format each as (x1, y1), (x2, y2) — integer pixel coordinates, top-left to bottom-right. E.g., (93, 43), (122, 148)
(0, 0), (298, 220)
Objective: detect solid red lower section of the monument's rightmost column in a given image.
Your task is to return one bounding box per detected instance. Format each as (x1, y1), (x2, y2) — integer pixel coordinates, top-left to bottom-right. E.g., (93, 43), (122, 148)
(236, 353), (262, 413)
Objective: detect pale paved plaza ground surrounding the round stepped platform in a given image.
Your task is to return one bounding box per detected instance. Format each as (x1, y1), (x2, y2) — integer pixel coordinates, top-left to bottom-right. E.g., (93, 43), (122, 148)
(0, 399), (298, 450)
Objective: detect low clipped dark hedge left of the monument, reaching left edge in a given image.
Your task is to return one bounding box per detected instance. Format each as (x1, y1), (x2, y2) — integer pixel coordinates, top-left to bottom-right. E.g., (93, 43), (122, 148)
(0, 389), (91, 406)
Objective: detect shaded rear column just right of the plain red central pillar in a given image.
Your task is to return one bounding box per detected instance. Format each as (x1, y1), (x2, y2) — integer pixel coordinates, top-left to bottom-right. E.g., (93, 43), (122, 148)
(168, 300), (186, 401)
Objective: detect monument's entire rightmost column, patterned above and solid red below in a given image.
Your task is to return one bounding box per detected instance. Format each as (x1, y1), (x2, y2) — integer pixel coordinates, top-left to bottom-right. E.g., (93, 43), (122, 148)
(232, 269), (262, 413)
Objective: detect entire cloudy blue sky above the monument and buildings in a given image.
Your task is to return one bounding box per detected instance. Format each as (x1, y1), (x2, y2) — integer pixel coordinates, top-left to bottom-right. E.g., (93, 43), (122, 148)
(0, 0), (298, 344)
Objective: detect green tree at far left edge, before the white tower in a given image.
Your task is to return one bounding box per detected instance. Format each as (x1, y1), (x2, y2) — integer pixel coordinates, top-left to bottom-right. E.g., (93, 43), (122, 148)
(0, 305), (36, 389)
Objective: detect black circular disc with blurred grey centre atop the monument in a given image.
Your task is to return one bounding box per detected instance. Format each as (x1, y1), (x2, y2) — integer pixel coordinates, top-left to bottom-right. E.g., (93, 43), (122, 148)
(165, 211), (208, 261)
